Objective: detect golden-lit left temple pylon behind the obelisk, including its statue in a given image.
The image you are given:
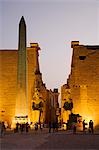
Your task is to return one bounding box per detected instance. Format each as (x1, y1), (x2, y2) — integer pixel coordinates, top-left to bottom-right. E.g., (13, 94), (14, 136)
(0, 43), (59, 125)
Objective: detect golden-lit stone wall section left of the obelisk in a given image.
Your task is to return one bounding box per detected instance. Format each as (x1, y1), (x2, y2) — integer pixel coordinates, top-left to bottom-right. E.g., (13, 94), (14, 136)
(0, 50), (17, 124)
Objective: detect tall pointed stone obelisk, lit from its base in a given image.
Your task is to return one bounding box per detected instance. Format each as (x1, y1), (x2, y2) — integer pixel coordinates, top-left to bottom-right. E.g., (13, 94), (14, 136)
(15, 16), (28, 122)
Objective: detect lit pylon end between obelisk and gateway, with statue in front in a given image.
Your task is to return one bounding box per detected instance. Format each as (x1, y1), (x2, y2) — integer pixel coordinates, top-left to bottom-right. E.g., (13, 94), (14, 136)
(27, 43), (47, 125)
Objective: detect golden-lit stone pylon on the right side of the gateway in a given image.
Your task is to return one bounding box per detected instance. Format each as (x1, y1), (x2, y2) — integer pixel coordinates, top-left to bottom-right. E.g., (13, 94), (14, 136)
(62, 41), (99, 126)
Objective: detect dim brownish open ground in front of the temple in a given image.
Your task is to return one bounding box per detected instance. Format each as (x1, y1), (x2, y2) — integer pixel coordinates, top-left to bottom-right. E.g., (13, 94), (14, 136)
(0, 130), (99, 150)
